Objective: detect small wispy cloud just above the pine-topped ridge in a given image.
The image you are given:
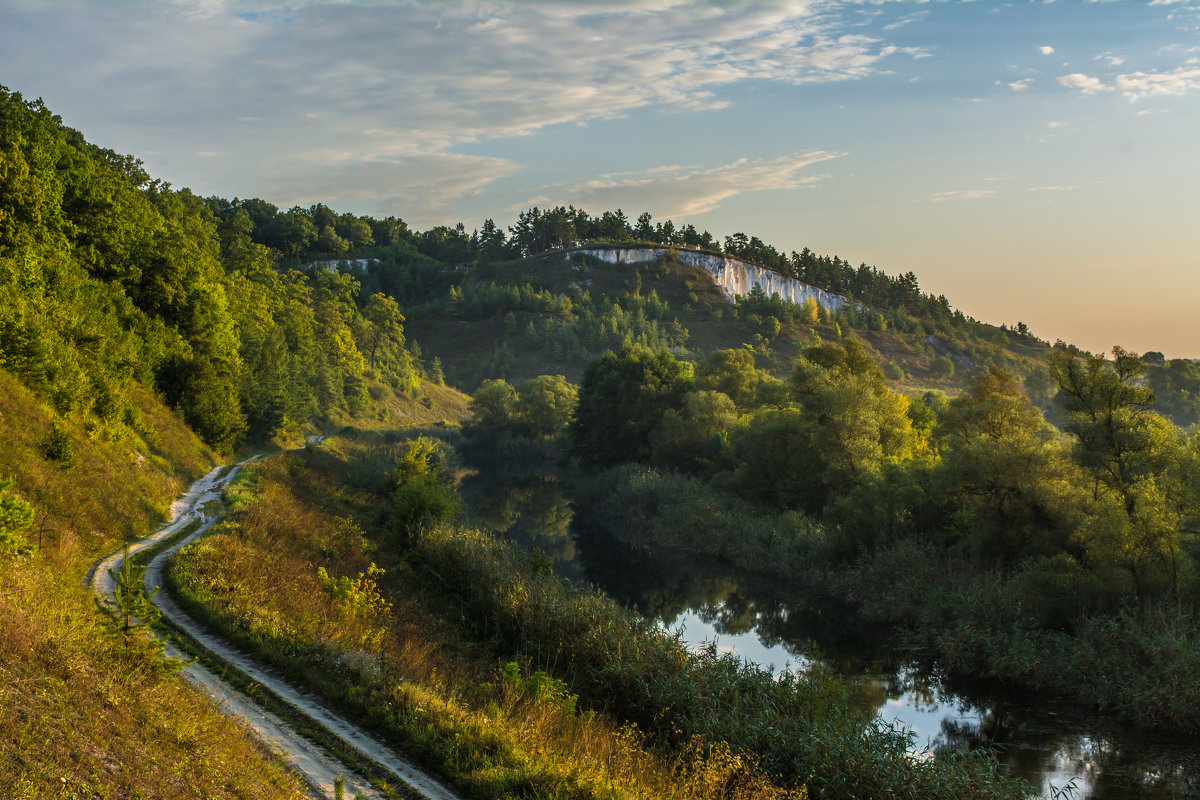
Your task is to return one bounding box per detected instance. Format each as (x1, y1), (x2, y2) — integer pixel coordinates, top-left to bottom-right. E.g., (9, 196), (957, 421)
(569, 150), (845, 218)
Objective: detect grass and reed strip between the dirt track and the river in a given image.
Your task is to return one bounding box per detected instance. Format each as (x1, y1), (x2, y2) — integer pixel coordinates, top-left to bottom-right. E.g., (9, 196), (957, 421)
(166, 443), (1027, 798)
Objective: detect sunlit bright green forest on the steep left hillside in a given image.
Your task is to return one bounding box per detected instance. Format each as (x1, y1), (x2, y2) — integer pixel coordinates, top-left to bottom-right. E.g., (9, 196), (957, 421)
(0, 90), (416, 450)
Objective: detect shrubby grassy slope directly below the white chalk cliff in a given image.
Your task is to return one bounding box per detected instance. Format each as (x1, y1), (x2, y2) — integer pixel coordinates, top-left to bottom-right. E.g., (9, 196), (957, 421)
(391, 245), (1050, 393)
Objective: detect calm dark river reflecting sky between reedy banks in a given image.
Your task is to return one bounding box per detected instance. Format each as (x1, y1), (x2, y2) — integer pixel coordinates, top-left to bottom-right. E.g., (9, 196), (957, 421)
(462, 470), (1200, 800)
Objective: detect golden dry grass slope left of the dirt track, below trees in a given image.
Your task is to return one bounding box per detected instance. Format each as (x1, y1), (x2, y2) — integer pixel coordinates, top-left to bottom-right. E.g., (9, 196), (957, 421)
(0, 371), (304, 800)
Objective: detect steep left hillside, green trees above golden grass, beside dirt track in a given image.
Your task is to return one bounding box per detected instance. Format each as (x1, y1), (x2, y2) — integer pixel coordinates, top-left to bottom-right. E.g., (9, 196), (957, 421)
(0, 88), (475, 798)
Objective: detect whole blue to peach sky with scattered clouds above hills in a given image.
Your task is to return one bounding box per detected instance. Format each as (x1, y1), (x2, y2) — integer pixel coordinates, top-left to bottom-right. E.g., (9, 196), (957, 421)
(0, 0), (1200, 357)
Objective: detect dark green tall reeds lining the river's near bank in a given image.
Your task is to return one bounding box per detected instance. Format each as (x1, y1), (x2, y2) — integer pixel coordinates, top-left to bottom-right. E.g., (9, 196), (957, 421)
(409, 527), (1028, 798)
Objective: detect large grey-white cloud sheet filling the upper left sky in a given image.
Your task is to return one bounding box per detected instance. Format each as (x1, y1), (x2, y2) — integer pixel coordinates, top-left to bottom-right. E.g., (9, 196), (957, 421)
(0, 0), (929, 213)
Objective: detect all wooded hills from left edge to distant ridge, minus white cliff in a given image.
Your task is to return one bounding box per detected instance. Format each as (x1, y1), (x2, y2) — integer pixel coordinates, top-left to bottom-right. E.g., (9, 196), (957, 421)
(0, 82), (1200, 462)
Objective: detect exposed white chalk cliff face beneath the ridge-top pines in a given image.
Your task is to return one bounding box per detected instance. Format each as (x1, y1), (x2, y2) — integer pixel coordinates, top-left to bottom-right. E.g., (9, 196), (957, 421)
(576, 247), (847, 311)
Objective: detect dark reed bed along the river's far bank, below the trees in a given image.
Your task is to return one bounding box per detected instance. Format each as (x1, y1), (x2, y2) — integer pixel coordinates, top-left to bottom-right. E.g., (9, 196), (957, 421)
(584, 465), (1200, 733)
